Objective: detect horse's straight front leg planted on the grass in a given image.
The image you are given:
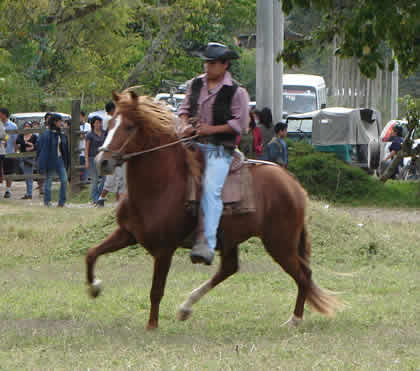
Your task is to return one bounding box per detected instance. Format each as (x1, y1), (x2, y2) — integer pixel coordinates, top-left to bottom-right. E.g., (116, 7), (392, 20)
(147, 249), (175, 330)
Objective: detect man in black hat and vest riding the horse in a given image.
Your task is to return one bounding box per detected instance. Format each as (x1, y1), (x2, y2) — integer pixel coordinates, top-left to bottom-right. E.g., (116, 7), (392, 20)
(179, 43), (249, 265)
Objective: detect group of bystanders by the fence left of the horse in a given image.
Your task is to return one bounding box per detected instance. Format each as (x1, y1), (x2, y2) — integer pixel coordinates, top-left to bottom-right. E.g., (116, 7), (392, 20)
(0, 102), (125, 207)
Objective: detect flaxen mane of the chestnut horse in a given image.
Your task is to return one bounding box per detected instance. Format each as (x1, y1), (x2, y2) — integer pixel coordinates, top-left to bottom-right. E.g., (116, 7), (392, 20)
(113, 90), (202, 183)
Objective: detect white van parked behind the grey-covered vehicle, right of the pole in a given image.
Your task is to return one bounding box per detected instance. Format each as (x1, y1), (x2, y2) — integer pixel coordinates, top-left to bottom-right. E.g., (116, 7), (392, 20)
(283, 74), (327, 115)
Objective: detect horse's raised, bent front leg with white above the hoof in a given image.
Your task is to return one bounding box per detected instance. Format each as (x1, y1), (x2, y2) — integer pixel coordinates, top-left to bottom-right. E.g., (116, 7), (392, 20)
(86, 227), (136, 298)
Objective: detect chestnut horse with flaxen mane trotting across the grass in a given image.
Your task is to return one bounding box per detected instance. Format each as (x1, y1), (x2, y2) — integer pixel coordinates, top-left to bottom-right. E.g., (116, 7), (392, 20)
(86, 91), (338, 329)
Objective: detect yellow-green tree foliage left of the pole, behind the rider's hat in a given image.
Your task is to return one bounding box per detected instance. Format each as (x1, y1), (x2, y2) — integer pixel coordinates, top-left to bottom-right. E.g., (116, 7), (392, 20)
(0, 0), (255, 111)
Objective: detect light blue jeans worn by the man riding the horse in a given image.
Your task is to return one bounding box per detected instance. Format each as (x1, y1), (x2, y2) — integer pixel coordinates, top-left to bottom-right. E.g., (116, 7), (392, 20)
(197, 143), (232, 250)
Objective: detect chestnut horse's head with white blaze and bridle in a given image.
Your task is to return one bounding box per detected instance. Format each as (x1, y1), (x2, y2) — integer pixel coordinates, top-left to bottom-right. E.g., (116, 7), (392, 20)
(95, 91), (175, 174)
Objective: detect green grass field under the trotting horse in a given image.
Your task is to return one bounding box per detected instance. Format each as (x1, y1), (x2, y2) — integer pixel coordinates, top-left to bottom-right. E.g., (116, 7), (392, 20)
(0, 202), (420, 370)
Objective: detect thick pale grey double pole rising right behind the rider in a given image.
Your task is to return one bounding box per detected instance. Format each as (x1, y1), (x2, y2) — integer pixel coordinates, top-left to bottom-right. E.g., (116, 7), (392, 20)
(256, 0), (284, 122)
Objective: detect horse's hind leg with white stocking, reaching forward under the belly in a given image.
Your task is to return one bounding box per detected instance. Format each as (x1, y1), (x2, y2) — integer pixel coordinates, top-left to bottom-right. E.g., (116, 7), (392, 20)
(177, 246), (239, 321)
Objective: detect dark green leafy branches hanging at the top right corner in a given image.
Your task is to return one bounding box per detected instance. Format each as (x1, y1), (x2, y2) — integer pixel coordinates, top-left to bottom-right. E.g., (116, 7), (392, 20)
(279, 0), (420, 78)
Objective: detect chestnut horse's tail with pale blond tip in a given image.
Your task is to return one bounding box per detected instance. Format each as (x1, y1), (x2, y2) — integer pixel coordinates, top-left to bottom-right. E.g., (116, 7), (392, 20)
(298, 225), (343, 317)
